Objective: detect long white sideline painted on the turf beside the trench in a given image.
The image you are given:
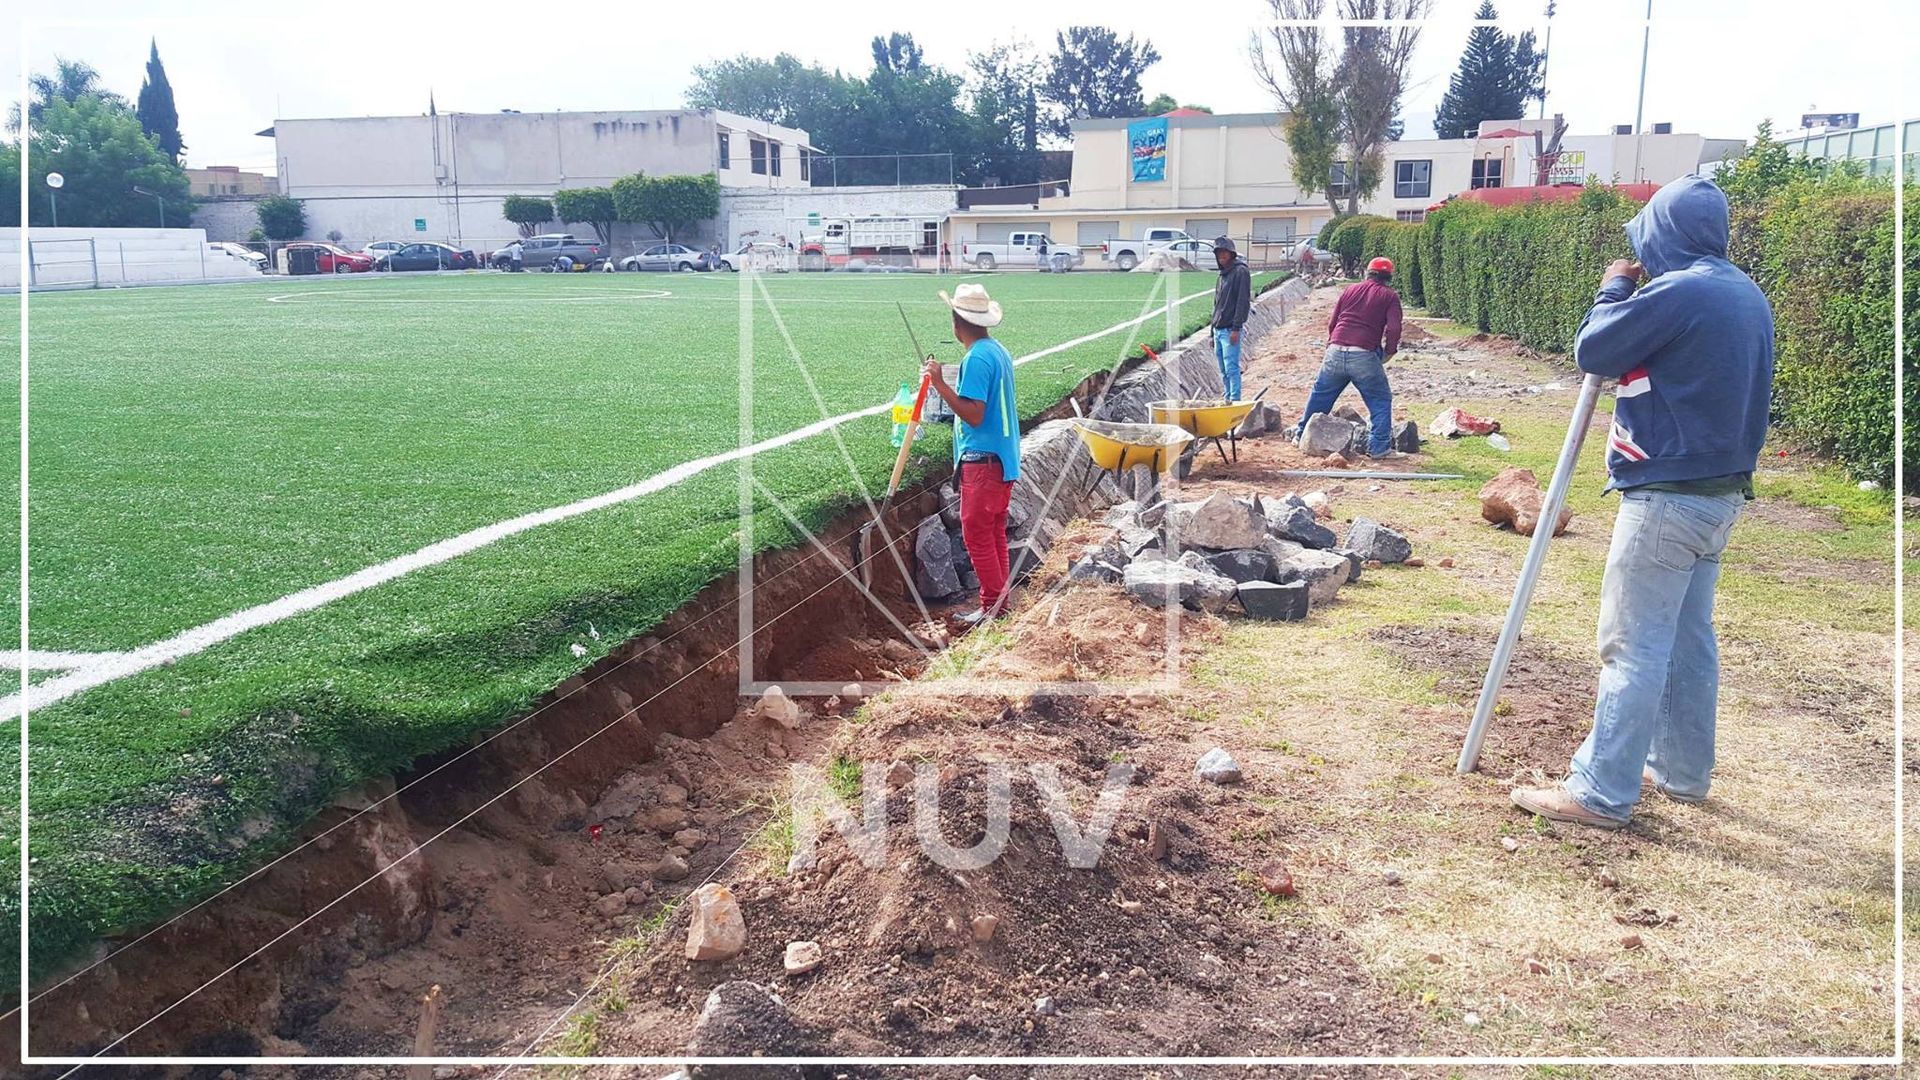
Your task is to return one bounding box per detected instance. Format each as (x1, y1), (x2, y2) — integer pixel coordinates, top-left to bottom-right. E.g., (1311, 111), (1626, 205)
(0, 290), (1212, 723)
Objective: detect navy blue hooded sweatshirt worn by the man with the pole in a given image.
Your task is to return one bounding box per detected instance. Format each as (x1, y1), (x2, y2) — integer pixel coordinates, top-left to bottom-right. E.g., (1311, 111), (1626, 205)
(1574, 177), (1774, 490)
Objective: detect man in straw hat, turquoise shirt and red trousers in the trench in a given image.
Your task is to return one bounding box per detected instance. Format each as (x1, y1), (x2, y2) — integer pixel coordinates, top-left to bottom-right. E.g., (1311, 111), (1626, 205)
(927, 281), (1020, 623)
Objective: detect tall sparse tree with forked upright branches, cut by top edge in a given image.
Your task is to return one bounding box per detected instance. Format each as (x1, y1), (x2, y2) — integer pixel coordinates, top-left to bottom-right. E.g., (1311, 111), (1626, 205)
(1252, 0), (1432, 213)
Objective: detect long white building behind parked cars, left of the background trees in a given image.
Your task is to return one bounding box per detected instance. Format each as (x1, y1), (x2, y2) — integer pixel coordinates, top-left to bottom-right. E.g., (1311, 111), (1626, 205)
(261, 110), (818, 252)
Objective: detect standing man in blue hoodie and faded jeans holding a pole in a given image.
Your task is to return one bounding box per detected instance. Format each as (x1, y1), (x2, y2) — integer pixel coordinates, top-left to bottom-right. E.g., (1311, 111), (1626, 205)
(1513, 177), (1774, 828)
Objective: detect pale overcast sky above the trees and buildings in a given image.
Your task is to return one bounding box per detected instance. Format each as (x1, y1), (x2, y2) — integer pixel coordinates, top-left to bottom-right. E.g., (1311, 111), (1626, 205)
(0, 0), (1914, 171)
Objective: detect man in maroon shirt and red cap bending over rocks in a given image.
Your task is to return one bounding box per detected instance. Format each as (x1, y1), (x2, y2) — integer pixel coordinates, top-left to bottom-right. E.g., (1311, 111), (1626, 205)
(1294, 259), (1400, 457)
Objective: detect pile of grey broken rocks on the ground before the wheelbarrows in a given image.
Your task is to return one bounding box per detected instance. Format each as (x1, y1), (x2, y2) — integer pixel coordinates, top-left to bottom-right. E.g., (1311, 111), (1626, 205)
(1068, 492), (1374, 621)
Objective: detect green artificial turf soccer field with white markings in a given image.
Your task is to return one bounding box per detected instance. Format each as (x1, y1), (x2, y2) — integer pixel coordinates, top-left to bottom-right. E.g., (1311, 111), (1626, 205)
(4, 273), (1259, 969)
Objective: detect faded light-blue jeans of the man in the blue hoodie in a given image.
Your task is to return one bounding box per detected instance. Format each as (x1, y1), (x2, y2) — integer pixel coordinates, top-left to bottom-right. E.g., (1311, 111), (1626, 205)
(1567, 490), (1745, 821)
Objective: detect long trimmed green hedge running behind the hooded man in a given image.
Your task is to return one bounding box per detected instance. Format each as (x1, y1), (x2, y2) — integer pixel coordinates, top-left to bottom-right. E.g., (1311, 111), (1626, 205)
(1332, 173), (1896, 482)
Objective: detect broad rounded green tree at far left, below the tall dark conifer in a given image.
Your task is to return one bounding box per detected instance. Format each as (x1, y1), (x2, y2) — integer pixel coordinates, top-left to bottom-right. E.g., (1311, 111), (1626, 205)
(15, 94), (194, 229)
